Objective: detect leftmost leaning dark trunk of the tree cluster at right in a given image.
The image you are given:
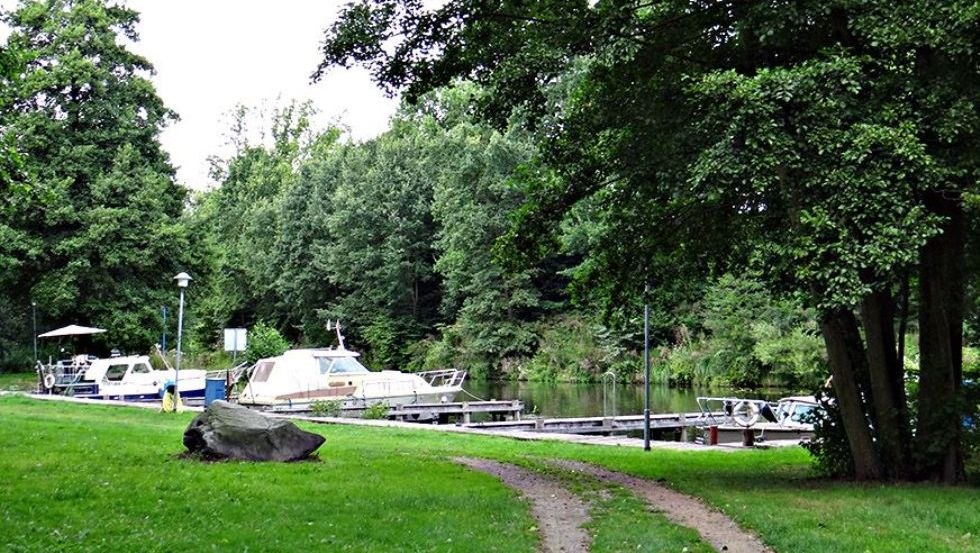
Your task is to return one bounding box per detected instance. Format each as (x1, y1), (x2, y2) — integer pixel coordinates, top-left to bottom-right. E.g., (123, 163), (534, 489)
(820, 310), (884, 480)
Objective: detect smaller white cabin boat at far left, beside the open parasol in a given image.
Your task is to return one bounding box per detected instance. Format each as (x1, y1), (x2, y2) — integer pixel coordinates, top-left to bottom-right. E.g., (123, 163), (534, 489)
(38, 355), (205, 401)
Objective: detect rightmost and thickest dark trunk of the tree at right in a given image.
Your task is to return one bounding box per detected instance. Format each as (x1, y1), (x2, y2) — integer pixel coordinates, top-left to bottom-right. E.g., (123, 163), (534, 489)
(916, 191), (965, 483)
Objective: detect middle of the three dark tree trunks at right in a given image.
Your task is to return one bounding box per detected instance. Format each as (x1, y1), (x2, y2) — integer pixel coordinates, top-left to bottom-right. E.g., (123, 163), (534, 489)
(861, 292), (912, 480)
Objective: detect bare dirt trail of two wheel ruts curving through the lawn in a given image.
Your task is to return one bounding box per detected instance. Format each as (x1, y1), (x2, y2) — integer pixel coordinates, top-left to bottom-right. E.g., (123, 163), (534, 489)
(455, 457), (772, 553)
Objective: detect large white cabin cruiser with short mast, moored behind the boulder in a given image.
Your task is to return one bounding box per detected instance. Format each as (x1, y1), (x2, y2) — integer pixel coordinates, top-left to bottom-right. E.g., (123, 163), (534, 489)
(238, 327), (466, 409)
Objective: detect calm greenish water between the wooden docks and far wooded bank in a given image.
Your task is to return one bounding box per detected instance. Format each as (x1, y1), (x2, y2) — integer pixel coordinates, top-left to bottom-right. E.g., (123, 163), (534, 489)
(456, 380), (789, 417)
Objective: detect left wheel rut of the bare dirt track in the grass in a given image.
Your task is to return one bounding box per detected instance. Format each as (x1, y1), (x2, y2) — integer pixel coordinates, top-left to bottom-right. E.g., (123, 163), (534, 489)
(455, 457), (590, 553)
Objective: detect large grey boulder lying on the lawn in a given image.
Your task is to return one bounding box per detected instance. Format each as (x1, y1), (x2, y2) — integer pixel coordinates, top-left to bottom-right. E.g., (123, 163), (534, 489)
(184, 400), (324, 461)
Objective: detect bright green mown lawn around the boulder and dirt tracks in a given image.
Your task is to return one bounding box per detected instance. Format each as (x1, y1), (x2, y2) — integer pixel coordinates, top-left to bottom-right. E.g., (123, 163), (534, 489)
(0, 397), (980, 552)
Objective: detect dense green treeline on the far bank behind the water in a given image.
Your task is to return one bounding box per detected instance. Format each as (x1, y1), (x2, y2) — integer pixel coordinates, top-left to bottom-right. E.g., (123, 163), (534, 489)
(188, 84), (826, 389)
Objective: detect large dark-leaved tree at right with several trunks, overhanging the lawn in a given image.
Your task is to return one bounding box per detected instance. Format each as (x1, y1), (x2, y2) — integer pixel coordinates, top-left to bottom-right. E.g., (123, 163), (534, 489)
(321, 0), (980, 482)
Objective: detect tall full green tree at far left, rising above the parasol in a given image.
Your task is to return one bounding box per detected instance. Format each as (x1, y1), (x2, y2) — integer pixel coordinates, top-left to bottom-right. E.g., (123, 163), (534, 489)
(0, 0), (187, 349)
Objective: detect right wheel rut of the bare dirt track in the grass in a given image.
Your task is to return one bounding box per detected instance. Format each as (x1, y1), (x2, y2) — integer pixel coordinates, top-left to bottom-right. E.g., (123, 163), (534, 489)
(554, 461), (772, 553)
